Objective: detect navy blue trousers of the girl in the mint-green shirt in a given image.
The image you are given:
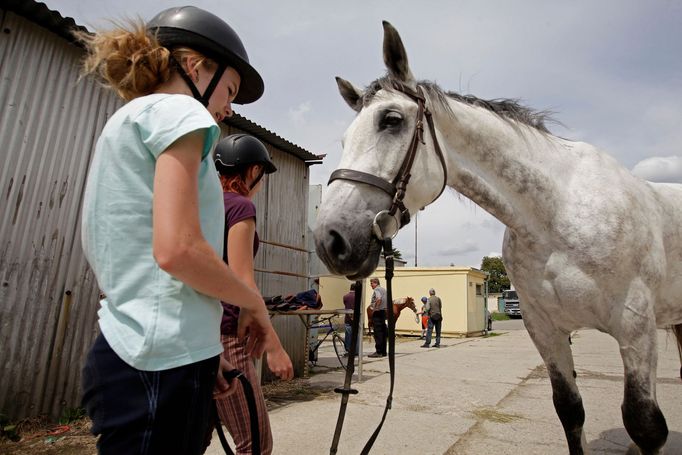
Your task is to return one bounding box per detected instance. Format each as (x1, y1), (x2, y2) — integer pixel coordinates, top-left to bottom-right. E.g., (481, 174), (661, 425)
(82, 334), (219, 455)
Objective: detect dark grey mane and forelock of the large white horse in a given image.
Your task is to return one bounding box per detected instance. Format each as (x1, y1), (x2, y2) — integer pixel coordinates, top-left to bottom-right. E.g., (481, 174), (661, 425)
(362, 76), (555, 133)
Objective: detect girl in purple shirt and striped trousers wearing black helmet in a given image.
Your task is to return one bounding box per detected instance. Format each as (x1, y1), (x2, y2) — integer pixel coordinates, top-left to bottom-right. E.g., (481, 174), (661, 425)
(213, 134), (294, 455)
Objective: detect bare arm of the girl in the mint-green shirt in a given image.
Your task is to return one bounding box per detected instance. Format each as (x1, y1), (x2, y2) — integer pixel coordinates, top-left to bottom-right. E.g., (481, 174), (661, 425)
(153, 131), (272, 355)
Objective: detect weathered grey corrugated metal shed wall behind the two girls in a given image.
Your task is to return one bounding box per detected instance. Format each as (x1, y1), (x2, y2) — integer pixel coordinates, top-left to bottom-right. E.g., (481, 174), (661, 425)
(0, 10), (308, 418)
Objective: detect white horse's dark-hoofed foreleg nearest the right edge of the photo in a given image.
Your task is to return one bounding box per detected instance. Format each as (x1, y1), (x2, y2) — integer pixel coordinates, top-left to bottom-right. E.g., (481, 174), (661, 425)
(616, 307), (668, 455)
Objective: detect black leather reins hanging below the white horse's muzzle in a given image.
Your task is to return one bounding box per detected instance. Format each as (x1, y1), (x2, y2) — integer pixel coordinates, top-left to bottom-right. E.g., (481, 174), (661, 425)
(329, 237), (395, 455)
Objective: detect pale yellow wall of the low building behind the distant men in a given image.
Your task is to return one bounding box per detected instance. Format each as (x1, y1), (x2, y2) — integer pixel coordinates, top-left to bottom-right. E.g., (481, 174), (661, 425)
(320, 267), (486, 336)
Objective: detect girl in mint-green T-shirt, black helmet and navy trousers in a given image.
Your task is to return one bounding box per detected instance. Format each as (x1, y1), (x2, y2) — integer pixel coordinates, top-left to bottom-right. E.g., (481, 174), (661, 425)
(74, 6), (276, 455)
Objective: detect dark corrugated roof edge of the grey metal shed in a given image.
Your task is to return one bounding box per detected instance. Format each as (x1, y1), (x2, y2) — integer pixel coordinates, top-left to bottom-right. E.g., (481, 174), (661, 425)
(0, 0), (325, 165)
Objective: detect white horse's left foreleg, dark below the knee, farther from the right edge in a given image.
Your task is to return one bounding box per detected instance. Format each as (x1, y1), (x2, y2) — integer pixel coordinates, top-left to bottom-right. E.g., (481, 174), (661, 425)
(524, 314), (587, 455)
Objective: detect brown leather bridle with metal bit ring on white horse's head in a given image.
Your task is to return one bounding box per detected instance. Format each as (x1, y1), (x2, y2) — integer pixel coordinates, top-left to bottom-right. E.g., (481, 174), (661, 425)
(327, 81), (448, 239)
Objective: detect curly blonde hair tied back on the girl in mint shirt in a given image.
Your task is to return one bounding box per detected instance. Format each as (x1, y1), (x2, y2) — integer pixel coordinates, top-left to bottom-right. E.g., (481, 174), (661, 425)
(74, 19), (215, 101)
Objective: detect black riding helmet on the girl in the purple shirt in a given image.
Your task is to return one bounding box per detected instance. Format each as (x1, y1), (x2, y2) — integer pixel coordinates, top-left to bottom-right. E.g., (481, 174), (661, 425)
(213, 134), (277, 174)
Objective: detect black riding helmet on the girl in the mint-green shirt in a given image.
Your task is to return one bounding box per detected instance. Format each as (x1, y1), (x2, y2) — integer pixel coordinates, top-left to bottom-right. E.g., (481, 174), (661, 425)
(147, 6), (264, 106)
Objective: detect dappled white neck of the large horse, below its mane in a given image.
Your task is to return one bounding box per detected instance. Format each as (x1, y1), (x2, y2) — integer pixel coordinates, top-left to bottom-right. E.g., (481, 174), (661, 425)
(434, 100), (568, 235)
